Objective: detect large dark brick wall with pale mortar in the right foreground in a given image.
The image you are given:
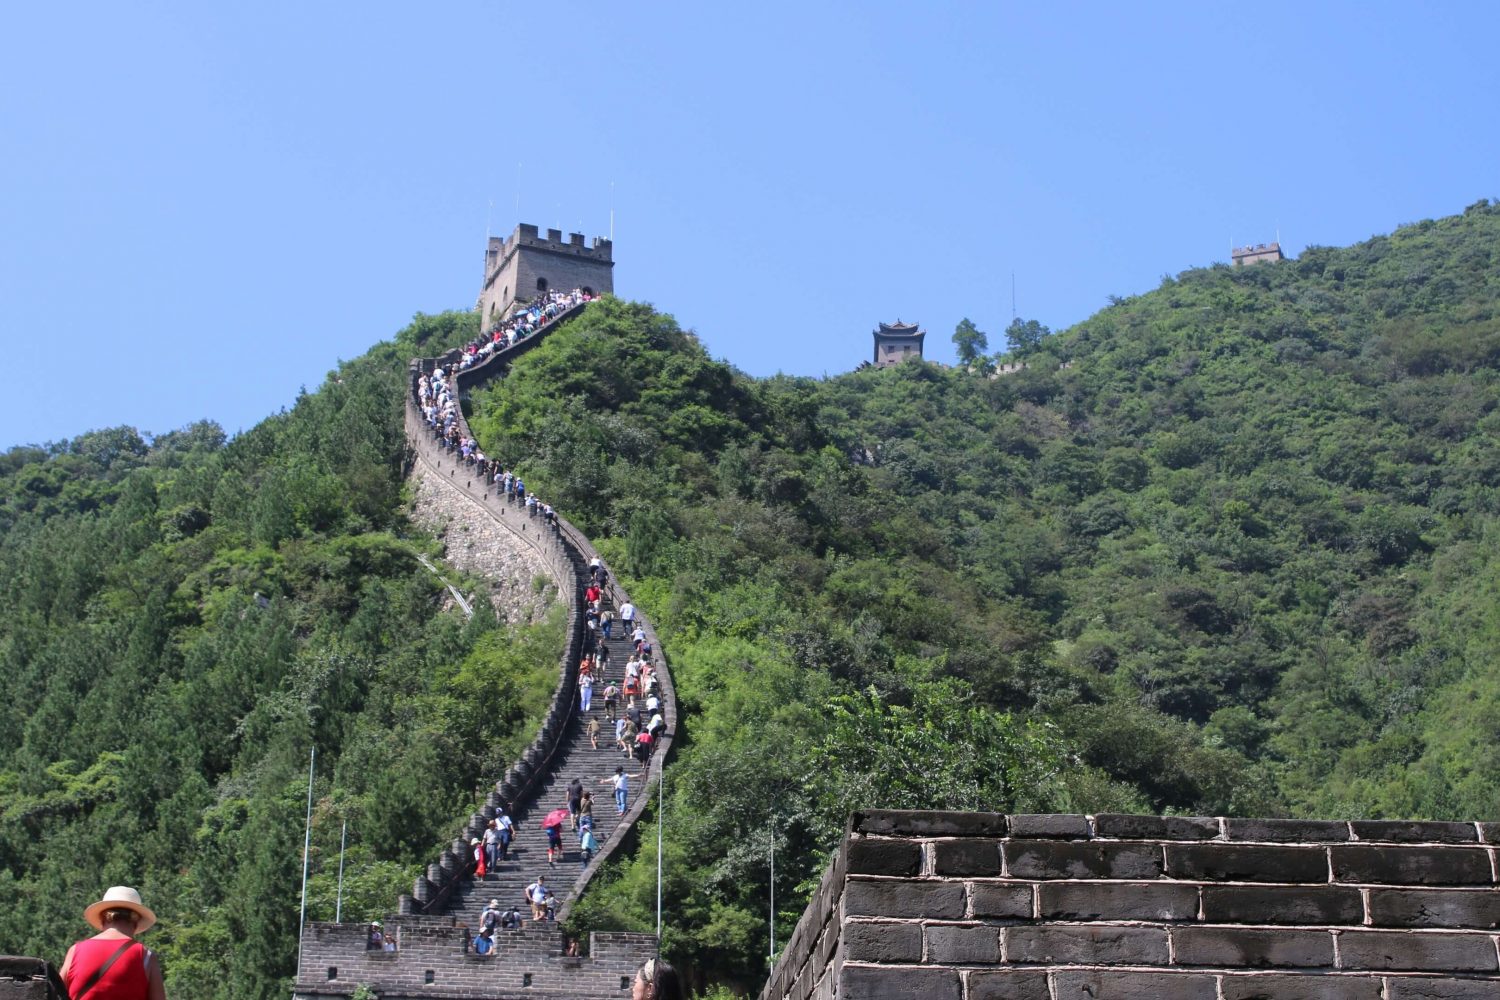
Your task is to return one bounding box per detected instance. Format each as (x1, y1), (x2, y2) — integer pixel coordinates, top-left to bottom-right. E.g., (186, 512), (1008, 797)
(761, 811), (1500, 1000)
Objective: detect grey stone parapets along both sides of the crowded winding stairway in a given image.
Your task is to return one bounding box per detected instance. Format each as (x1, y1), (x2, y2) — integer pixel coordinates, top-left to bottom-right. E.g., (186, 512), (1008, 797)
(402, 303), (678, 921)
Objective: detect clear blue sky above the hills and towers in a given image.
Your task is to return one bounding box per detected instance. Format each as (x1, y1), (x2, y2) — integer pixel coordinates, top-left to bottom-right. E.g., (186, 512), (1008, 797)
(0, 0), (1500, 447)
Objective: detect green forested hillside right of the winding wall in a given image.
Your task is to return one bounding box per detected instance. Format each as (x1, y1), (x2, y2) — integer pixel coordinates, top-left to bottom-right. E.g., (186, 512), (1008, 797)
(473, 202), (1500, 982)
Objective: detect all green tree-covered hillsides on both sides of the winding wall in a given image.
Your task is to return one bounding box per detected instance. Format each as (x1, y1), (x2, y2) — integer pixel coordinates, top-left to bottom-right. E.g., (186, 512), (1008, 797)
(0, 202), (1500, 999)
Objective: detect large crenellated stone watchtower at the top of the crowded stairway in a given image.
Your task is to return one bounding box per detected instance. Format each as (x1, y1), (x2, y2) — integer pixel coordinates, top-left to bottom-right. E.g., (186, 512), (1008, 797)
(479, 223), (615, 327)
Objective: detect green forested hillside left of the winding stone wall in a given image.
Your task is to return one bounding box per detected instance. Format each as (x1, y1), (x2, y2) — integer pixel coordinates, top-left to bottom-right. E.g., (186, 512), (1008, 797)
(0, 313), (563, 1000)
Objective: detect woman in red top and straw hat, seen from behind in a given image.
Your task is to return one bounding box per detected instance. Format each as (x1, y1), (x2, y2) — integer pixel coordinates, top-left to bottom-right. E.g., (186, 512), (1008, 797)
(62, 886), (167, 1000)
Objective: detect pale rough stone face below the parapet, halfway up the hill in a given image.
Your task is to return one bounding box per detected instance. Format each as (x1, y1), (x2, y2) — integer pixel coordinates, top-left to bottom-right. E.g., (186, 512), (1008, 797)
(408, 465), (560, 625)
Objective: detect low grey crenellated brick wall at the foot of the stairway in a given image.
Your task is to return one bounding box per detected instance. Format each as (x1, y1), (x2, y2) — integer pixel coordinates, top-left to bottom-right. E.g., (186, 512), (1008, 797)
(294, 916), (656, 1000)
